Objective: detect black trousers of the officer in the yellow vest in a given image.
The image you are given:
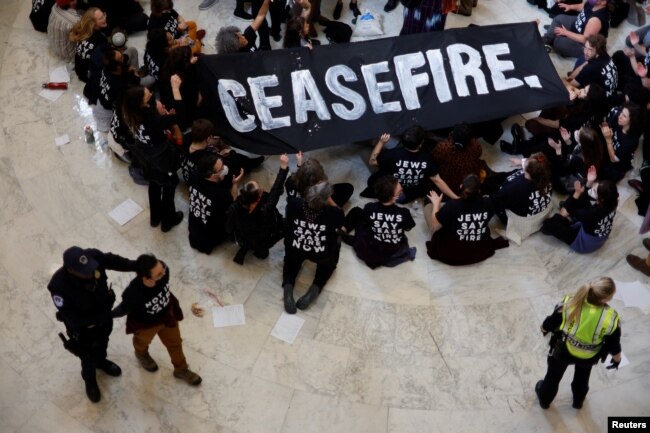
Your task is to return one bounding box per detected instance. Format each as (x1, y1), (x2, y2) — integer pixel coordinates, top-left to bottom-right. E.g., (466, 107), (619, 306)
(539, 356), (593, 405)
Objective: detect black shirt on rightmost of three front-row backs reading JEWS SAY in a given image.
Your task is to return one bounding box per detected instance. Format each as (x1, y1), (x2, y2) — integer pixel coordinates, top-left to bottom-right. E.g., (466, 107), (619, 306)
(436, 197), (494, 243)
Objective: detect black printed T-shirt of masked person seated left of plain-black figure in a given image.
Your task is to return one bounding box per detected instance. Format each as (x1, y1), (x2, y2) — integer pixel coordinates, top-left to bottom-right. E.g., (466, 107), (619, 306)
(188, 173), (233, 246)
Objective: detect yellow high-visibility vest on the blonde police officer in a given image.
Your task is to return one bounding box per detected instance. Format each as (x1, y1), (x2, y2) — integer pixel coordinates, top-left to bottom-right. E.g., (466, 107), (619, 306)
(560, 296), (619, 359)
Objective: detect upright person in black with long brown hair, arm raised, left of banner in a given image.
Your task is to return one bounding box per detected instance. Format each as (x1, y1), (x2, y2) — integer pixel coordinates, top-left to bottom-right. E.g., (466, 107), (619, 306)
(122, 75), (183, 232)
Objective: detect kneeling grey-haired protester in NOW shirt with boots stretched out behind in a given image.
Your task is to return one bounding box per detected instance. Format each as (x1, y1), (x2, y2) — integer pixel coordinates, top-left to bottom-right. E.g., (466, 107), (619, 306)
(282, 181), (344, 314)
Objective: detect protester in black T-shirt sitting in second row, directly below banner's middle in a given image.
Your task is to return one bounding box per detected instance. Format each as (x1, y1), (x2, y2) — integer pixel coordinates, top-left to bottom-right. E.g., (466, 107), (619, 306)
(361, 125), (458, 204)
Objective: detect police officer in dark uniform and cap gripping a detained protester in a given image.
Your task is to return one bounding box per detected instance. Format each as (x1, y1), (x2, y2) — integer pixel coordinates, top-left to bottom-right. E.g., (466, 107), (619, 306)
(47, 246), (135, 403)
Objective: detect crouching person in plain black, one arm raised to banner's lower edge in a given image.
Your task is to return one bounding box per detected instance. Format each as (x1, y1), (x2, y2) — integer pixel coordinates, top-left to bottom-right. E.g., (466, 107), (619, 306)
(226, 154), (289, 265)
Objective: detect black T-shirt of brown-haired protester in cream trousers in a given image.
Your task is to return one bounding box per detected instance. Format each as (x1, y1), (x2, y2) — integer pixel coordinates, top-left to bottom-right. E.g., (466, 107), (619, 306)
(491, 170), (551, 217)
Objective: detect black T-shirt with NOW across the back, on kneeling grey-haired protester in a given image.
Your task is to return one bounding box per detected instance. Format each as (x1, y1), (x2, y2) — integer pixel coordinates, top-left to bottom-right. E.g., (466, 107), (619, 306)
(284, 197), (344, 262)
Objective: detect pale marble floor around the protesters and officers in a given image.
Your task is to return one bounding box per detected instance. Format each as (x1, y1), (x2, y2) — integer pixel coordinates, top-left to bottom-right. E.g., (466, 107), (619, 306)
(0, 0), (650, 433)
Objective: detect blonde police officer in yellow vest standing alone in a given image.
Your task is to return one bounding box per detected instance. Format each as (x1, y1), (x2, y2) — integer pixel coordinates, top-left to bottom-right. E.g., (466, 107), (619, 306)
(535, 277), (621, 409)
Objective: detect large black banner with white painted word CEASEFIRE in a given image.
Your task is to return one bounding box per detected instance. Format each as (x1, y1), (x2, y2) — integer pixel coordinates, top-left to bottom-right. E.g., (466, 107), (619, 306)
(197, 23), (568, 154)
